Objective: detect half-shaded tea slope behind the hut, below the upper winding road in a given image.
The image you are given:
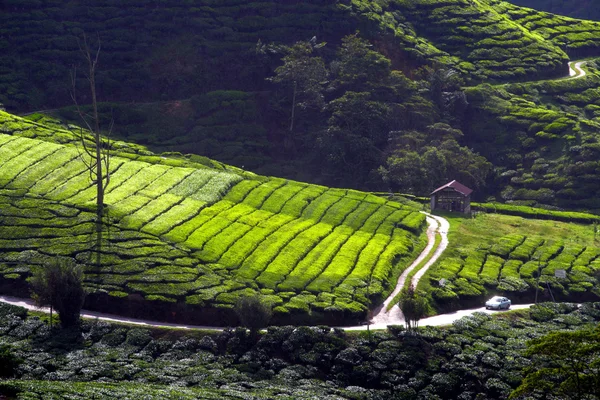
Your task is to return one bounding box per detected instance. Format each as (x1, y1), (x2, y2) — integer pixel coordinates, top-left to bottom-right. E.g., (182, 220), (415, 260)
(466, 60), (600, 209)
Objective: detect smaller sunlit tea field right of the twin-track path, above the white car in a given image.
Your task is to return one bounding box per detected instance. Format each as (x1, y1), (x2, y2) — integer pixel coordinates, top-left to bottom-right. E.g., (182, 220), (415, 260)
(422, 214), (600, 304)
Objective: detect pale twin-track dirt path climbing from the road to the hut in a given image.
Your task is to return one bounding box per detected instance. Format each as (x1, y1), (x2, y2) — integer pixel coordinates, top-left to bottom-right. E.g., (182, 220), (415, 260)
(371, 212), (450, 327)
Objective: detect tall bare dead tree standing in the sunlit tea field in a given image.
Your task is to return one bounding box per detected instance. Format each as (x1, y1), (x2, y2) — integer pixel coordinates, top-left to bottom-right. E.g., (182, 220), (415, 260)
(71, 33), (113, 267)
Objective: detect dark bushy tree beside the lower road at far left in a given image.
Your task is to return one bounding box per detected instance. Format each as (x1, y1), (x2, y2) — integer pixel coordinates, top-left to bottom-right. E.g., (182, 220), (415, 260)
(29, 260), (86, 328)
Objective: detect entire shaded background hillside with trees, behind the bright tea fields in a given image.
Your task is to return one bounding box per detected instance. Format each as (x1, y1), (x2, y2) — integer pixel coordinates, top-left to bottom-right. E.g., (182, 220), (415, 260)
(0, 0), (600, 210)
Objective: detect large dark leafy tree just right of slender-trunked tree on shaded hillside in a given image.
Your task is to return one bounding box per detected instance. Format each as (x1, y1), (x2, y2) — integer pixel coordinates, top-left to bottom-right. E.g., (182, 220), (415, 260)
(318, 34), (415, 185)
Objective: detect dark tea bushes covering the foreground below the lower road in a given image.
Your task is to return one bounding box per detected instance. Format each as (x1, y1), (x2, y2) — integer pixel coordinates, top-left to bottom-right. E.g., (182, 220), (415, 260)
(0, 303), (600, 400)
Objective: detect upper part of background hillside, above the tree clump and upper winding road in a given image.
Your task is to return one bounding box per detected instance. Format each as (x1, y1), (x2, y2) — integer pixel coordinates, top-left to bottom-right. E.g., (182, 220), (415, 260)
(0, 0), (600, 110)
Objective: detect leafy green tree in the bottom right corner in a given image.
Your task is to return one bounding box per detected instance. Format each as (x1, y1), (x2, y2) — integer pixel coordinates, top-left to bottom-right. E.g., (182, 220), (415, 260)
(510, 327), (600, 400)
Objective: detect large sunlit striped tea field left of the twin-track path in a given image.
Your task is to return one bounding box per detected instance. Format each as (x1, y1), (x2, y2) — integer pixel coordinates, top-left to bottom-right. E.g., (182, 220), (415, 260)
(0, 114), (425, 319)
